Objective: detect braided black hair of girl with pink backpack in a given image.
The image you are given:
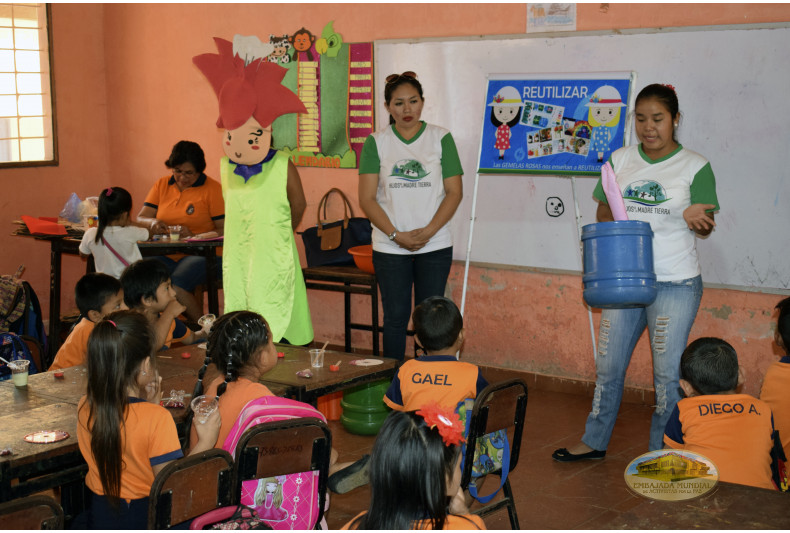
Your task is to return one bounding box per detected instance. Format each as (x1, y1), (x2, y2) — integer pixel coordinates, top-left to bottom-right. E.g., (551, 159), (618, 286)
(185, 311), (270, 446)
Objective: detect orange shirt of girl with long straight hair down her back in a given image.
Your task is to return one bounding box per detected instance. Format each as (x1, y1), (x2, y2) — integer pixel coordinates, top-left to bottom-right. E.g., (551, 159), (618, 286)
(77, 396), (184, 500)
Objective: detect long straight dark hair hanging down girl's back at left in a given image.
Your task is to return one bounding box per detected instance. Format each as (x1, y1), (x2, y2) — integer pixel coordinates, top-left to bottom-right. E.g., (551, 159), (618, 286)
(83, 311), (154, 507)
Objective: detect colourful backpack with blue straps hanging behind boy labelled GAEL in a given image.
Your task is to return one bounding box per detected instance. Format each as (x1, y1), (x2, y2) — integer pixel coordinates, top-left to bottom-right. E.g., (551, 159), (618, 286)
(457, 399), (510, 504)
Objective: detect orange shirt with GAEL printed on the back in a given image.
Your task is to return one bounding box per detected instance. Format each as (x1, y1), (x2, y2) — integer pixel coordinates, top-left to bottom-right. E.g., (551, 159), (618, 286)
(384, 355), (488, 411)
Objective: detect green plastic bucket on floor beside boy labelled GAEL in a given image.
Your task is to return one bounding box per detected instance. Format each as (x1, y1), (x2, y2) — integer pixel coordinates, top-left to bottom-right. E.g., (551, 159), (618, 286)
(340, 379), (390, 435)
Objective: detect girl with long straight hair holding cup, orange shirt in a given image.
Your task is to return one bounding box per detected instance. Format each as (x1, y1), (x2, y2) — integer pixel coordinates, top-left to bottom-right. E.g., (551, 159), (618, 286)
(77, 311), (220, 529)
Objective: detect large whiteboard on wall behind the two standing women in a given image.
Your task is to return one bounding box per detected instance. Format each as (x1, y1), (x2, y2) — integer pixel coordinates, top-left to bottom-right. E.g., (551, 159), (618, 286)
(375, 27), (790, 292)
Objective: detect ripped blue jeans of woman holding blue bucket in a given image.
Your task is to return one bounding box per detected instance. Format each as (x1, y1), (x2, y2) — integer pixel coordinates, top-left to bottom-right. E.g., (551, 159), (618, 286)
(582, 276), (702, 450)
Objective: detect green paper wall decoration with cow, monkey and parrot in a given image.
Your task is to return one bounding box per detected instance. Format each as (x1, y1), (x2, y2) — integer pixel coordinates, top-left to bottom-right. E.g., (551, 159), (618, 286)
(268, 22), (373, 168)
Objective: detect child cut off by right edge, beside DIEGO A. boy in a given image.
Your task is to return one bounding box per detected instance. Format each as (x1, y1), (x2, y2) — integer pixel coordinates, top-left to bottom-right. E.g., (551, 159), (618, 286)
(760, 298), (790, 457)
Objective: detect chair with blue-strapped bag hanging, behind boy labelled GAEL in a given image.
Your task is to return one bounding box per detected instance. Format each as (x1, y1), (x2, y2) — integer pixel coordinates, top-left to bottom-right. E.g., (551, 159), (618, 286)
(461, 379), (527, 529)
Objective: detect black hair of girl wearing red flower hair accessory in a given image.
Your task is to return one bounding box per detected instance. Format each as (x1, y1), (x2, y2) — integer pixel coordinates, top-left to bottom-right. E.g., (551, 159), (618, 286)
(350, 411), (464, 530)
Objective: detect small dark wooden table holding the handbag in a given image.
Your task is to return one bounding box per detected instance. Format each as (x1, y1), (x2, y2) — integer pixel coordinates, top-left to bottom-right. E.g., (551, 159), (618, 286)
(302, 266), (379, 355)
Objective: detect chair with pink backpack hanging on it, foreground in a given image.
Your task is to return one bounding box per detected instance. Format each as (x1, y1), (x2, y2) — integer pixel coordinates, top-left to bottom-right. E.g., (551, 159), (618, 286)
(235, 418), (332, 529)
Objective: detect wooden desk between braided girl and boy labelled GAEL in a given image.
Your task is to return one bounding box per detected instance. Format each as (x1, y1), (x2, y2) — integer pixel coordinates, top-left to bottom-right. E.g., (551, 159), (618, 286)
(261, 344), (399, 405)
